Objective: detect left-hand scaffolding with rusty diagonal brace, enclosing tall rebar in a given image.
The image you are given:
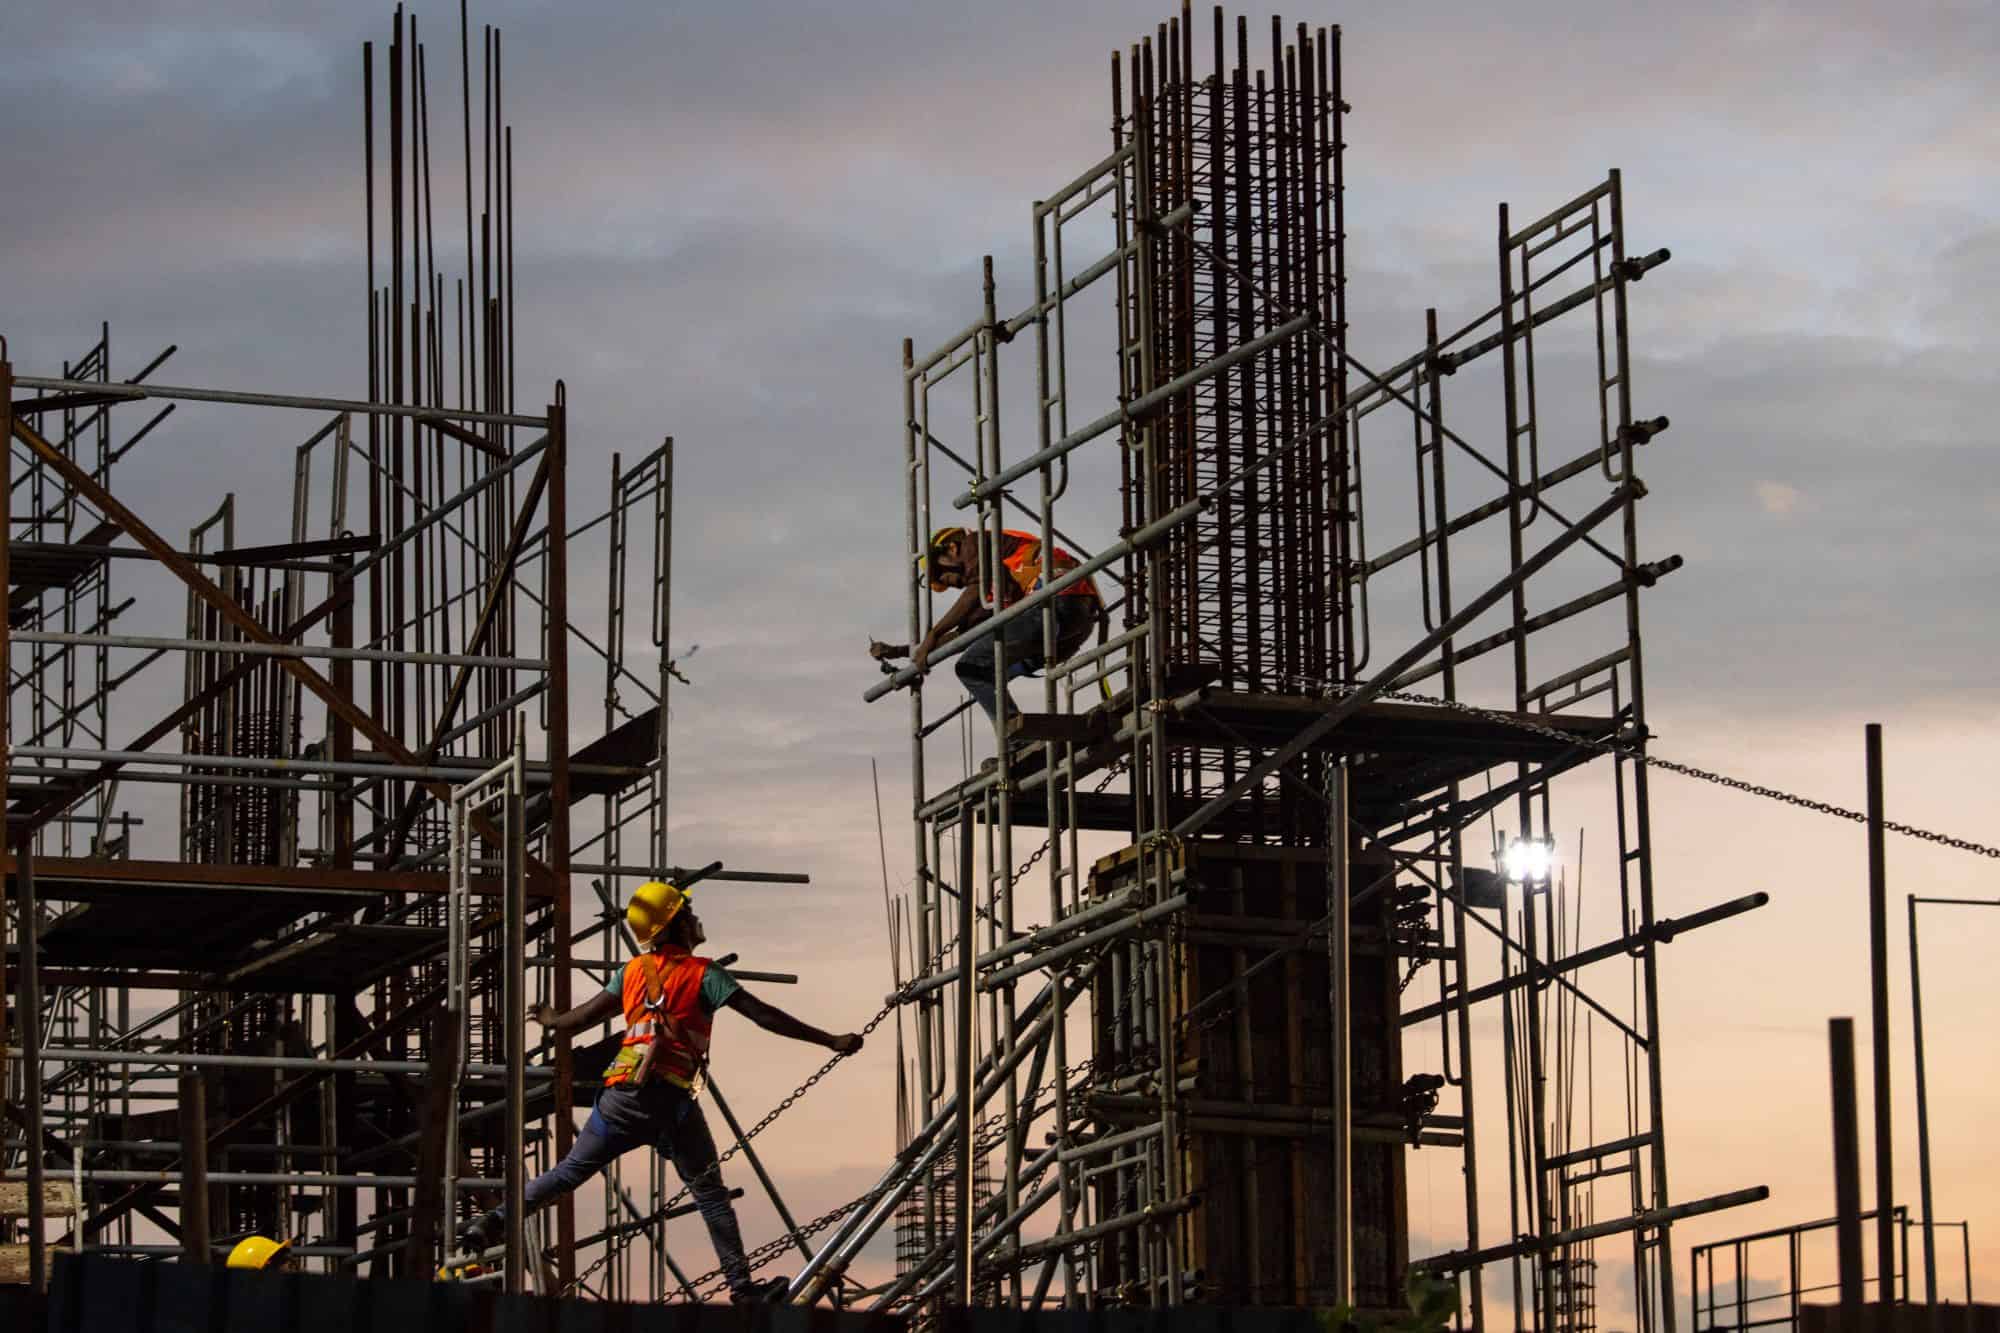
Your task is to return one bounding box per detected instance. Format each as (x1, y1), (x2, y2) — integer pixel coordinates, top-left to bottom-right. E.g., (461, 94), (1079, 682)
(0, 6), (808, 1299)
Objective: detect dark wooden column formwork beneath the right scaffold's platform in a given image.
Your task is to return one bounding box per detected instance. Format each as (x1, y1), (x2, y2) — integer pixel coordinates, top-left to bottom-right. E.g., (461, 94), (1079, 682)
(1092, 843), (1408, 1309)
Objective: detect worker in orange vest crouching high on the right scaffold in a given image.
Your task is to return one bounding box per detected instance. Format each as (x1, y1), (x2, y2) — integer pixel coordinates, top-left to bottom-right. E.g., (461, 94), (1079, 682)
(868, 528), (1104, 721)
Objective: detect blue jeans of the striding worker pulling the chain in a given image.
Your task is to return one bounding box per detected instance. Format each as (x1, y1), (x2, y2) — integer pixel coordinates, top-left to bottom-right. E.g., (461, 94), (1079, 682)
(492, 1083), (750, 1291)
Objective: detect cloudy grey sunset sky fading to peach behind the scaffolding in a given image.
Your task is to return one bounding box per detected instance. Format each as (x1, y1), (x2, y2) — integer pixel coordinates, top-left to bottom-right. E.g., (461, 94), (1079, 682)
(0, 0), (2000, 1329)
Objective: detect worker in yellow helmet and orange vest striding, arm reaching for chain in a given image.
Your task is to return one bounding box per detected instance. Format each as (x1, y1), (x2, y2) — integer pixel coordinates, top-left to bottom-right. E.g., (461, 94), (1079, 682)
(462, 881), (862, 1305)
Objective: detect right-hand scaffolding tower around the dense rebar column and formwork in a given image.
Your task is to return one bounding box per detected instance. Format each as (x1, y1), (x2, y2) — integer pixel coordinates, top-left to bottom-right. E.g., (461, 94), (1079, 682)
(844, 4), (1764, 1333)
